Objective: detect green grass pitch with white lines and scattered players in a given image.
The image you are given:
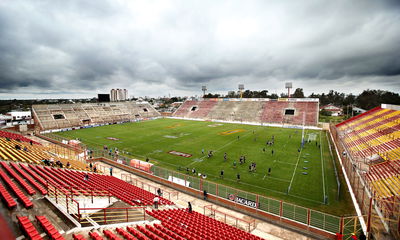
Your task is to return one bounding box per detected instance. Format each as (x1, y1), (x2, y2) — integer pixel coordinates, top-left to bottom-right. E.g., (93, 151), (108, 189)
(53, 119), (353, 215)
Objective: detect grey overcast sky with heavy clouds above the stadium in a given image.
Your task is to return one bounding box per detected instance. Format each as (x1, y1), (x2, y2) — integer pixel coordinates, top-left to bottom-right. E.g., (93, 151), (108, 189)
(0, 0), (400, 99)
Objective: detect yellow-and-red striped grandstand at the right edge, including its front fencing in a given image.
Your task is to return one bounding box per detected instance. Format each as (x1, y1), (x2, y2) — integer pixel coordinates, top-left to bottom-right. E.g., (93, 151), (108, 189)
(332, 104), (400, 236)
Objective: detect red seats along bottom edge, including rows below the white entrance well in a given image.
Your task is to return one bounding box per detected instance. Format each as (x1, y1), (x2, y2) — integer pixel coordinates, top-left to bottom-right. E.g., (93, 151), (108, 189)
(77, 218), (262, 240)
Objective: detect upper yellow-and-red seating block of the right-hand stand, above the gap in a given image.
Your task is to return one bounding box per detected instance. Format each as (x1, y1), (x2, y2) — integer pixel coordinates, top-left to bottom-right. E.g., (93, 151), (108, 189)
(337, 108), (400, 160)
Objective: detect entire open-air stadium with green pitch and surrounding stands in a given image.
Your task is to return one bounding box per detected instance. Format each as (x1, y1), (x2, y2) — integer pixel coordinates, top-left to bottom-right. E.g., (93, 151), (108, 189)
(0, 93), (400, 239)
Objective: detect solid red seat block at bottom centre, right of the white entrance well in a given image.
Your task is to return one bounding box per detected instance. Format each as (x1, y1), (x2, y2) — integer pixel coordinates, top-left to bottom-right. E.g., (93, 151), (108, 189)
(147, 209), (261, 240)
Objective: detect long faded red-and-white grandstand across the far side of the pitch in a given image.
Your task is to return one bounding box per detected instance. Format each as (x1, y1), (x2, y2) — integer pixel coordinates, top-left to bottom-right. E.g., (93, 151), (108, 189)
(172, 98), (319, 126)
